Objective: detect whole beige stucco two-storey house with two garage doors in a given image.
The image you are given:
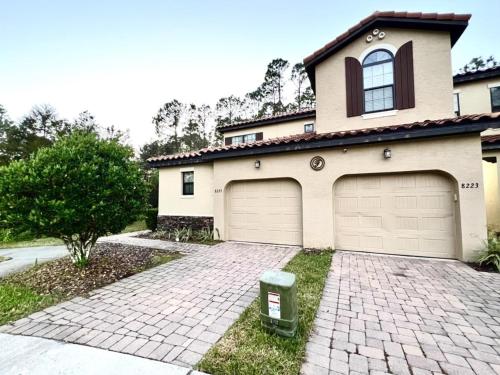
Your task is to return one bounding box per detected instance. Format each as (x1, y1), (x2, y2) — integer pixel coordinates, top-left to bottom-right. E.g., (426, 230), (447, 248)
(149, 12), (500, 260)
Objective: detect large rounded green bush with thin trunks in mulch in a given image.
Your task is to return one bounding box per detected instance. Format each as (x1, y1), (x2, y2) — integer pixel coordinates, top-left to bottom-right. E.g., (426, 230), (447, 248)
(0, 133), (147, 266)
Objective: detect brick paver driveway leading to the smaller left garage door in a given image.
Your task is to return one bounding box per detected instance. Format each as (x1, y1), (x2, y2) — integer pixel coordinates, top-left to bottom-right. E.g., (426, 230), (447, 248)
(0, 242), (298, 367)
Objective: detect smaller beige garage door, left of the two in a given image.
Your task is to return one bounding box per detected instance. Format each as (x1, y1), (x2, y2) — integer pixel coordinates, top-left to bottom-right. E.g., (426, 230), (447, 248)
(228, 180), (302, 245)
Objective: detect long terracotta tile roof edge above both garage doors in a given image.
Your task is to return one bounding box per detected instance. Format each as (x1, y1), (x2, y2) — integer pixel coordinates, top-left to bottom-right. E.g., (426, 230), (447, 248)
(148, 113), (500, 163)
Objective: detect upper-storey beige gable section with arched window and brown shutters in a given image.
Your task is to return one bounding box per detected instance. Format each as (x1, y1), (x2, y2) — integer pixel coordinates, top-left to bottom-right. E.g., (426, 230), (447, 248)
(304, 12), (470, 132)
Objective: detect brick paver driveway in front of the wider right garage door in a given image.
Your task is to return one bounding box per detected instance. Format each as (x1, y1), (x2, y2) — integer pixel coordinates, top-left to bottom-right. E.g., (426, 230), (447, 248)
(302, 252), (500, 375)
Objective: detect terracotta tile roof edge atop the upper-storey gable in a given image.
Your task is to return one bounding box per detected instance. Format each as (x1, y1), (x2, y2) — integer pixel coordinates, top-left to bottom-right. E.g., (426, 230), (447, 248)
(304, 11), (471, 64)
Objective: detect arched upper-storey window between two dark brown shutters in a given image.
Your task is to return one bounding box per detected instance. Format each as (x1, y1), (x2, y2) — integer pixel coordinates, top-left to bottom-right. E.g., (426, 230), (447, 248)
(363, 50), (394, 113)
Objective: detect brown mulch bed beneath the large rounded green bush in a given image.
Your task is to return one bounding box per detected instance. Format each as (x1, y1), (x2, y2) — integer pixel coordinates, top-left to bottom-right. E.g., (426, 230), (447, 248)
(1, 243), (181, 297)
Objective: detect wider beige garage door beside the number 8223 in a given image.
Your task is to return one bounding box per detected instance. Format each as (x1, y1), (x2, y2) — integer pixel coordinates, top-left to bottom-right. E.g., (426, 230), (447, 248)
(334, 173), (456, 258)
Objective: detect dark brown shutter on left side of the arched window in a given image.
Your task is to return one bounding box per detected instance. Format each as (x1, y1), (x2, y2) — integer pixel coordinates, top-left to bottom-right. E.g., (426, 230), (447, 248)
(345, 57), (363, 117)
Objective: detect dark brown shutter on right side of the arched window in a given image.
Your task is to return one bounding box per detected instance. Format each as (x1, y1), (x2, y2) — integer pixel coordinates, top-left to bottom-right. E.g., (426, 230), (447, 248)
(394, 41), (415, 109)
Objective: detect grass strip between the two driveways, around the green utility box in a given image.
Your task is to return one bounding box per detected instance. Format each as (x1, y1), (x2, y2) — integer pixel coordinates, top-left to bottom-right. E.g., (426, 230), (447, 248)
(198, 251), (332, 375)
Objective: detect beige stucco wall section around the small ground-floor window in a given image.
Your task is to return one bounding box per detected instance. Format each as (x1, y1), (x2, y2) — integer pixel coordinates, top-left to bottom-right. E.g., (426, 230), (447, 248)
(158, 164), (214, 216)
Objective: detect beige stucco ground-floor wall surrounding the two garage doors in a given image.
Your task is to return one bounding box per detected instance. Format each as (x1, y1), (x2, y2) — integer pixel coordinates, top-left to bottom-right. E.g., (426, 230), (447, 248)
(160, 135), (486, 260)
